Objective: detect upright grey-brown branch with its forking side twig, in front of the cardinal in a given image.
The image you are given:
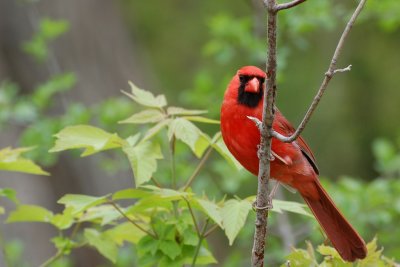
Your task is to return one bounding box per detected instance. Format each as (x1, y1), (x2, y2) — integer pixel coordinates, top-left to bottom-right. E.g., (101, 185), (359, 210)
(249, 0), (366, 267)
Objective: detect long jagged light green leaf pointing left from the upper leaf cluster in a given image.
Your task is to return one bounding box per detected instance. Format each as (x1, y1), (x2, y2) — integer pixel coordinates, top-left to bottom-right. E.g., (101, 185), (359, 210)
(49, 125), (124, 156)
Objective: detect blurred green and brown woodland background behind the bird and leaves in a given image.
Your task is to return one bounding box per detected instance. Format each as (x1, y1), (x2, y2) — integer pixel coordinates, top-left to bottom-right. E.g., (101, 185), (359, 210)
(0, 0), (400, 266)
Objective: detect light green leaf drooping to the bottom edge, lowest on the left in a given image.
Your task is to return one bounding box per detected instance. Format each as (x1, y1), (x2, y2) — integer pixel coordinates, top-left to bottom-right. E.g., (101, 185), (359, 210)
(84, 228), (118, 263)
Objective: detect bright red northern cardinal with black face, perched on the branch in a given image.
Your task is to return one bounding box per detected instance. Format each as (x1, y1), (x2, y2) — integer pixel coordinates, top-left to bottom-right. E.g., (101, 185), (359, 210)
(221, 66), (367, 262)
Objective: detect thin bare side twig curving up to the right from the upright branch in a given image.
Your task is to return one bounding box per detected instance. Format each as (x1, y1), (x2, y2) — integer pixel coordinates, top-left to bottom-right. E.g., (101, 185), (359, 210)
(272, 0), (367, 143)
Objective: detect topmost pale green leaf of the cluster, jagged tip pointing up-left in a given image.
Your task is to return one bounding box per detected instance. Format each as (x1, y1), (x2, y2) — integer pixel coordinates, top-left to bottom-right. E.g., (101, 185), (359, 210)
(122, 82), (167, 108)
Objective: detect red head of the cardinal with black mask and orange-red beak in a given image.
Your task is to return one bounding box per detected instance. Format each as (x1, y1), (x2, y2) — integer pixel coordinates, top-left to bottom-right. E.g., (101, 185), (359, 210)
(230, 66), (267, 108)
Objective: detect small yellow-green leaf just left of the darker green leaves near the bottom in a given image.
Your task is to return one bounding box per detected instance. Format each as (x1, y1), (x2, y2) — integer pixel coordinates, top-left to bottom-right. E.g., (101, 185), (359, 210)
(104, 222), (147, 246)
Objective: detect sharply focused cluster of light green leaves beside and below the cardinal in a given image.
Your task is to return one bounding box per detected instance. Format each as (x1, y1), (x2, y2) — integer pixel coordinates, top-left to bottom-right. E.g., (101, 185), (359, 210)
(0, 83), (309, 266)
